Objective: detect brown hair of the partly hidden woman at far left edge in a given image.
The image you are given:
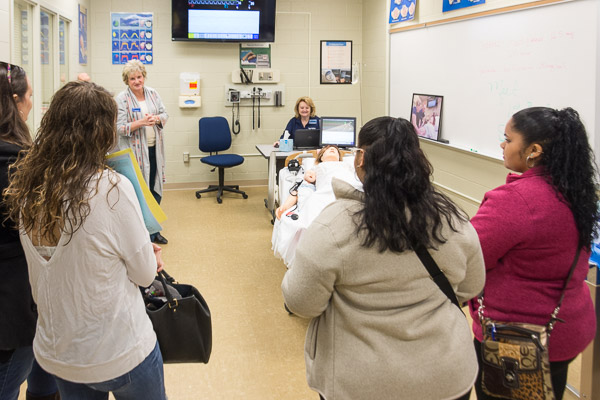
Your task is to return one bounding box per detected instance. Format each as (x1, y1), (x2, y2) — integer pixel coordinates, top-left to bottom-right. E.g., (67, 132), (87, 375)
(0, 62), (31, 148)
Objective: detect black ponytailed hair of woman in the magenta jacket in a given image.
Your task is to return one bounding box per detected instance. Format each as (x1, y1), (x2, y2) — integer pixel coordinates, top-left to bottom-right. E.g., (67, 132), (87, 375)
(512, 107), (600, 248)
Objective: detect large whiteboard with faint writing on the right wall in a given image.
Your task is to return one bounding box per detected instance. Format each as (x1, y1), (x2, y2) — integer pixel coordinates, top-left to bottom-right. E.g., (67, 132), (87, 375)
(390, 0), (600, 159)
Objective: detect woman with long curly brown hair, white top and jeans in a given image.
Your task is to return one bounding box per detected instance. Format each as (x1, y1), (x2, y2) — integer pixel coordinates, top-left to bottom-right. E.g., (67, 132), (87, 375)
(5, 81), (166, 400)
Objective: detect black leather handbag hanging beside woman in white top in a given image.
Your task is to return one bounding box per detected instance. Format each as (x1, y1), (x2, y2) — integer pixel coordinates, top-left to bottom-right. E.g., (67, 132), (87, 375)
(144, 270), (212, 364)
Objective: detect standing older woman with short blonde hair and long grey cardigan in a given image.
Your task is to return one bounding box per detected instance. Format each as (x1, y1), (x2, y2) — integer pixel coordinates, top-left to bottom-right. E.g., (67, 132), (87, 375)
(115, 60), (169, 244)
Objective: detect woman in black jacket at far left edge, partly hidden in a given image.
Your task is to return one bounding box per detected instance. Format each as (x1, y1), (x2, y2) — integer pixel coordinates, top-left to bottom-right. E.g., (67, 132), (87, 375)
(0, 62), (58, 400)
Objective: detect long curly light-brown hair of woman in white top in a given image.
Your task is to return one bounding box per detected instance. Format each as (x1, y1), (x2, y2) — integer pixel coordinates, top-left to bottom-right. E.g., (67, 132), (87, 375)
(4, 81), (117, 243)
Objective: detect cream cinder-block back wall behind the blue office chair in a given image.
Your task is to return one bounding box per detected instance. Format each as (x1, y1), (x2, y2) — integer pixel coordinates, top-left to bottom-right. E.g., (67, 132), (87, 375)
(90, 0), (360, 183)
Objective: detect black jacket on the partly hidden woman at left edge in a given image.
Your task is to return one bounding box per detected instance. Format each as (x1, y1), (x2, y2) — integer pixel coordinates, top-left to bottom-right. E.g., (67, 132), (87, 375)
(0, 140), (37, 350)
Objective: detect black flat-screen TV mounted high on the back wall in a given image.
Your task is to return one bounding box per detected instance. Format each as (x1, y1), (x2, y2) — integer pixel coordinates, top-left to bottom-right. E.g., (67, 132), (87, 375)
(171, 0), (275, 42)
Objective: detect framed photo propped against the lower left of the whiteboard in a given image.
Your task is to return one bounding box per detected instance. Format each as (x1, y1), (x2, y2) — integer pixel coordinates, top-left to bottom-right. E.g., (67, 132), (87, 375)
(410, 93), (444, 140)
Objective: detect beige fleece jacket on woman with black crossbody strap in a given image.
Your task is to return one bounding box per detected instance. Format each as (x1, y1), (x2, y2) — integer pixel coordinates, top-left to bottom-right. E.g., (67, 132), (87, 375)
(282, 179), (485, 400)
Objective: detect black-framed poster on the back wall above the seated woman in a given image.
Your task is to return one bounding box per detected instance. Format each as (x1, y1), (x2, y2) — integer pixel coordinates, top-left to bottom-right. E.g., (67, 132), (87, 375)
(319, 40), (352, 85)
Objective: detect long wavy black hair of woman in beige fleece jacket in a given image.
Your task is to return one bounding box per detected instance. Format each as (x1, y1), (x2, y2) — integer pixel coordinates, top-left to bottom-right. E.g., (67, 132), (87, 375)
(356, 117), (468, 252)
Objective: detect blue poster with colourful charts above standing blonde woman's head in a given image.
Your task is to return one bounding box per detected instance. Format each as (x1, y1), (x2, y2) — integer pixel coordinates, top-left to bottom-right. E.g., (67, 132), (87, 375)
(110, 13), (154, 65)
